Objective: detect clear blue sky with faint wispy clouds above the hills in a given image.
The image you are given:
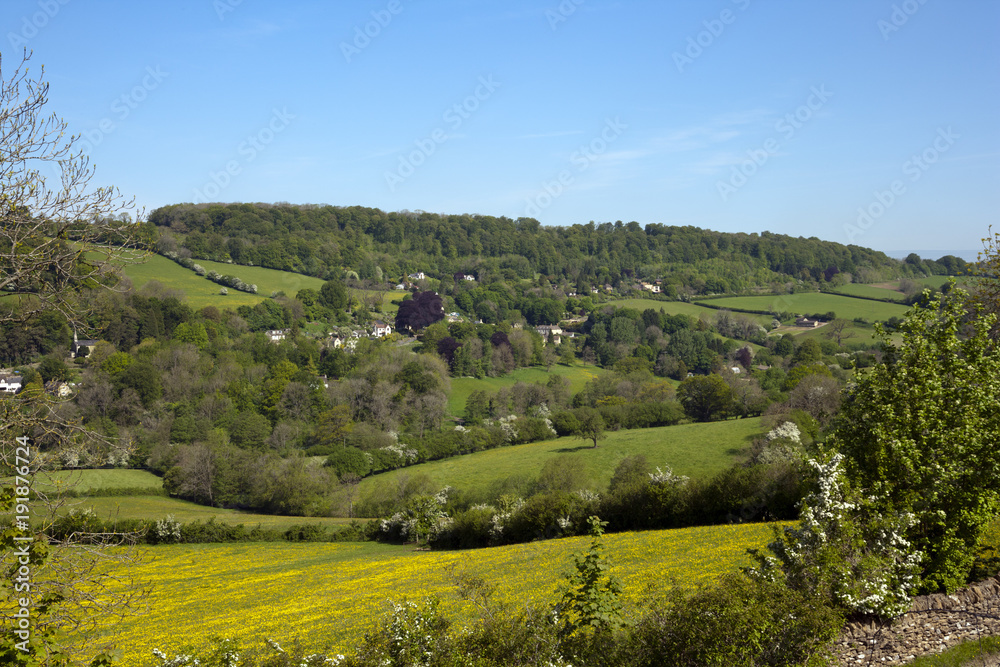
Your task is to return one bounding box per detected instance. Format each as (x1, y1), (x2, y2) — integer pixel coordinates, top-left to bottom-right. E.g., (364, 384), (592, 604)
(0, 0), (1000, 257)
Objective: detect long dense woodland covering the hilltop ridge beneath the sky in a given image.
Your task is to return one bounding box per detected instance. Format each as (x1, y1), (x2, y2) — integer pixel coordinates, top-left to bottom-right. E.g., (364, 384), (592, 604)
(149, 204), (964, 295)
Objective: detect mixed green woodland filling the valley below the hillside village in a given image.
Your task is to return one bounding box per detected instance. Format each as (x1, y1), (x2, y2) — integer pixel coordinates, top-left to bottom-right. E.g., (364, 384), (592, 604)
(0, 272), (866, 516)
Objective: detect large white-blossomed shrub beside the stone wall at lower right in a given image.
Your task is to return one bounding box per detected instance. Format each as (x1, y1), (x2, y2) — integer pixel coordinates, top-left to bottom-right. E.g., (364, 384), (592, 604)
(747, 454), (922, 618)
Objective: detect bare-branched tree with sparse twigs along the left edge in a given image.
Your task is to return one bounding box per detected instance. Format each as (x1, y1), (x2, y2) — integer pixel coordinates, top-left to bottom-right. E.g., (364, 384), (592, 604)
(0, 53), (145, 665)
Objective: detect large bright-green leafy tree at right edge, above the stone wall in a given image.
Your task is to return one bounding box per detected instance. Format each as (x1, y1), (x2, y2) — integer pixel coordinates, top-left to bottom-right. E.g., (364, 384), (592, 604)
(832, 289), (1000, 591)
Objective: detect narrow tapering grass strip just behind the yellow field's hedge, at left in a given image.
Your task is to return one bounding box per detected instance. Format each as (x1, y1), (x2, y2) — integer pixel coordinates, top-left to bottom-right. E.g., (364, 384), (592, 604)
(66, 496), (350, 529)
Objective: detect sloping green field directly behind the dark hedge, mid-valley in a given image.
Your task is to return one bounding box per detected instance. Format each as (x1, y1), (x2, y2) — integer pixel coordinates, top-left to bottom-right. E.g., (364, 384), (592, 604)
(359, 417), (762, 496)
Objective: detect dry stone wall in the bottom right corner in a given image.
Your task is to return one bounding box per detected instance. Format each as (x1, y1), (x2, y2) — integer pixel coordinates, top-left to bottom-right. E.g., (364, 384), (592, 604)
(835, 577), (1000, 667)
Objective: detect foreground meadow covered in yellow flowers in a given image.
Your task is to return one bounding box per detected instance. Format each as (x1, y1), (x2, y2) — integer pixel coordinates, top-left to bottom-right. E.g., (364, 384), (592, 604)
(97, 524), (784, 665)
